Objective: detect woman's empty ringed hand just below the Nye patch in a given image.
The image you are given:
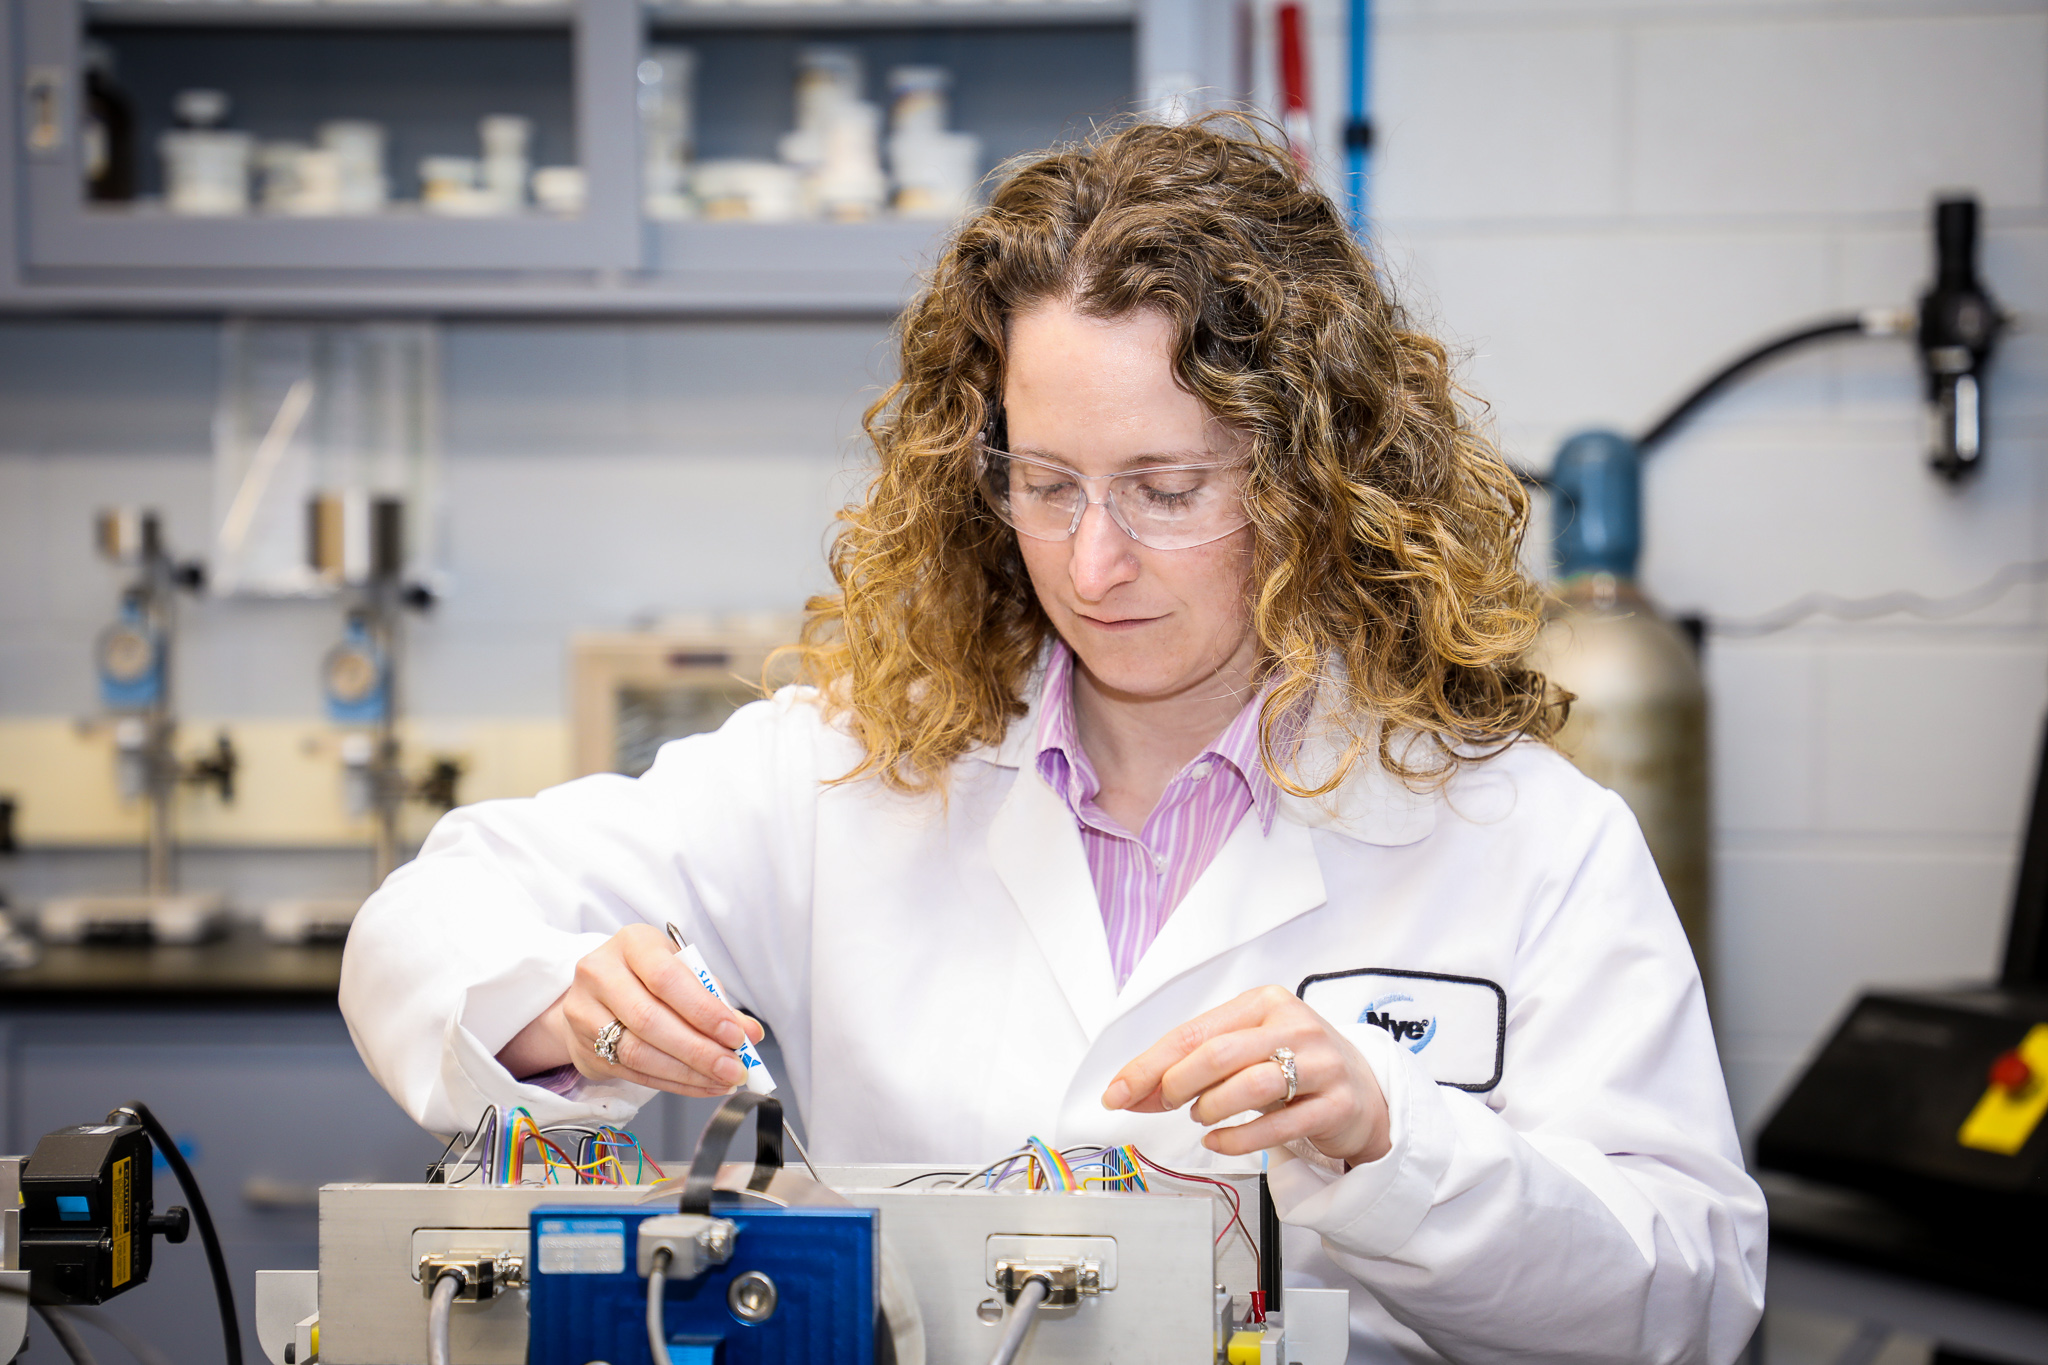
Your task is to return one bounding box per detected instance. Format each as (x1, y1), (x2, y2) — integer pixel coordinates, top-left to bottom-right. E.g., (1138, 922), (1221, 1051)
(1102, 986), (1393, 1164)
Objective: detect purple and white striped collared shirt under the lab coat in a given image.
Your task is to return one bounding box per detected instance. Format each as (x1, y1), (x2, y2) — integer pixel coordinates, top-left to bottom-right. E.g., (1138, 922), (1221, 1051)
(1036, 641), (1280, 988)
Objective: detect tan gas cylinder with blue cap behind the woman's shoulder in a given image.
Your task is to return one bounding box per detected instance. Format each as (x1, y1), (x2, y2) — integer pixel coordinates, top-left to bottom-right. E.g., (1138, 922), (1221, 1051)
(1530, 432), (1712, 994)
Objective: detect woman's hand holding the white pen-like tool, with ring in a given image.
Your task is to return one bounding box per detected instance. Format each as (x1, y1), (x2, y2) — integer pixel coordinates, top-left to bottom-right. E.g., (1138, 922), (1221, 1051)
(498, 925), (762, 1095)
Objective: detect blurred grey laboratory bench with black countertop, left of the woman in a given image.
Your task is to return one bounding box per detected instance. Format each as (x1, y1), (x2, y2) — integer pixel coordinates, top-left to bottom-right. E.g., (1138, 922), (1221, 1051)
(0, 927), (690, 1365)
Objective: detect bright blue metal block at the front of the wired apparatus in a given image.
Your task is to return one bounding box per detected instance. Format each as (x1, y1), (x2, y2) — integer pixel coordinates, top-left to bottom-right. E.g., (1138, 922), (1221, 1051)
(526, 1191), (881, 1365)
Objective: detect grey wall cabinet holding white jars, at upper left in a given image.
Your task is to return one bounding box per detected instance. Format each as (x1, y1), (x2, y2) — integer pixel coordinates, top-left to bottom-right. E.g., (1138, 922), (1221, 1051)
(0, 0), (1235, 313)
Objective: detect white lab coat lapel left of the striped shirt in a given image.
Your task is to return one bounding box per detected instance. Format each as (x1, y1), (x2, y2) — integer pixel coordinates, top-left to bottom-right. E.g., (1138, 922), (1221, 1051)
(989, 763), (1116, 1038)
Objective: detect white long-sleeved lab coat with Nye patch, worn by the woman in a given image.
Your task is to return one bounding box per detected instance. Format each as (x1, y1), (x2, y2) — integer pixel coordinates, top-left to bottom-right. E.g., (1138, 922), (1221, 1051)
(342, 690), (1765, 1365)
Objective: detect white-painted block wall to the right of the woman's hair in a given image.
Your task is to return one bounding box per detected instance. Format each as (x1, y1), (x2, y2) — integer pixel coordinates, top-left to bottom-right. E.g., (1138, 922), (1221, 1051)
(1351, 0), (2048, 1132)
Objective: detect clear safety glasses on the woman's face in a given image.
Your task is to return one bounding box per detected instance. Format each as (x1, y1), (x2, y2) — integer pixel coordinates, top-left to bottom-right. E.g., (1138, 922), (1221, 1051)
(981, 446), (1251, 551)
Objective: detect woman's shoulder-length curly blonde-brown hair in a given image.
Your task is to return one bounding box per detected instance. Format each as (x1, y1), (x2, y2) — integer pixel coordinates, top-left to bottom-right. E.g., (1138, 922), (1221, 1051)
(797, 115), (1567, 796)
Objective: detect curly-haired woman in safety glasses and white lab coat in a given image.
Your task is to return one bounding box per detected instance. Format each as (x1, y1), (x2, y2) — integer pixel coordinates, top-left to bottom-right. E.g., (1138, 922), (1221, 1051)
(342, 125), (1763, 1361)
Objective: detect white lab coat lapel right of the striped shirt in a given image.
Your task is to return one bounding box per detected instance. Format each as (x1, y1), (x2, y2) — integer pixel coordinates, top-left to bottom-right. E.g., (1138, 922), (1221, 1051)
(1116, 810), (1327, 1013)
